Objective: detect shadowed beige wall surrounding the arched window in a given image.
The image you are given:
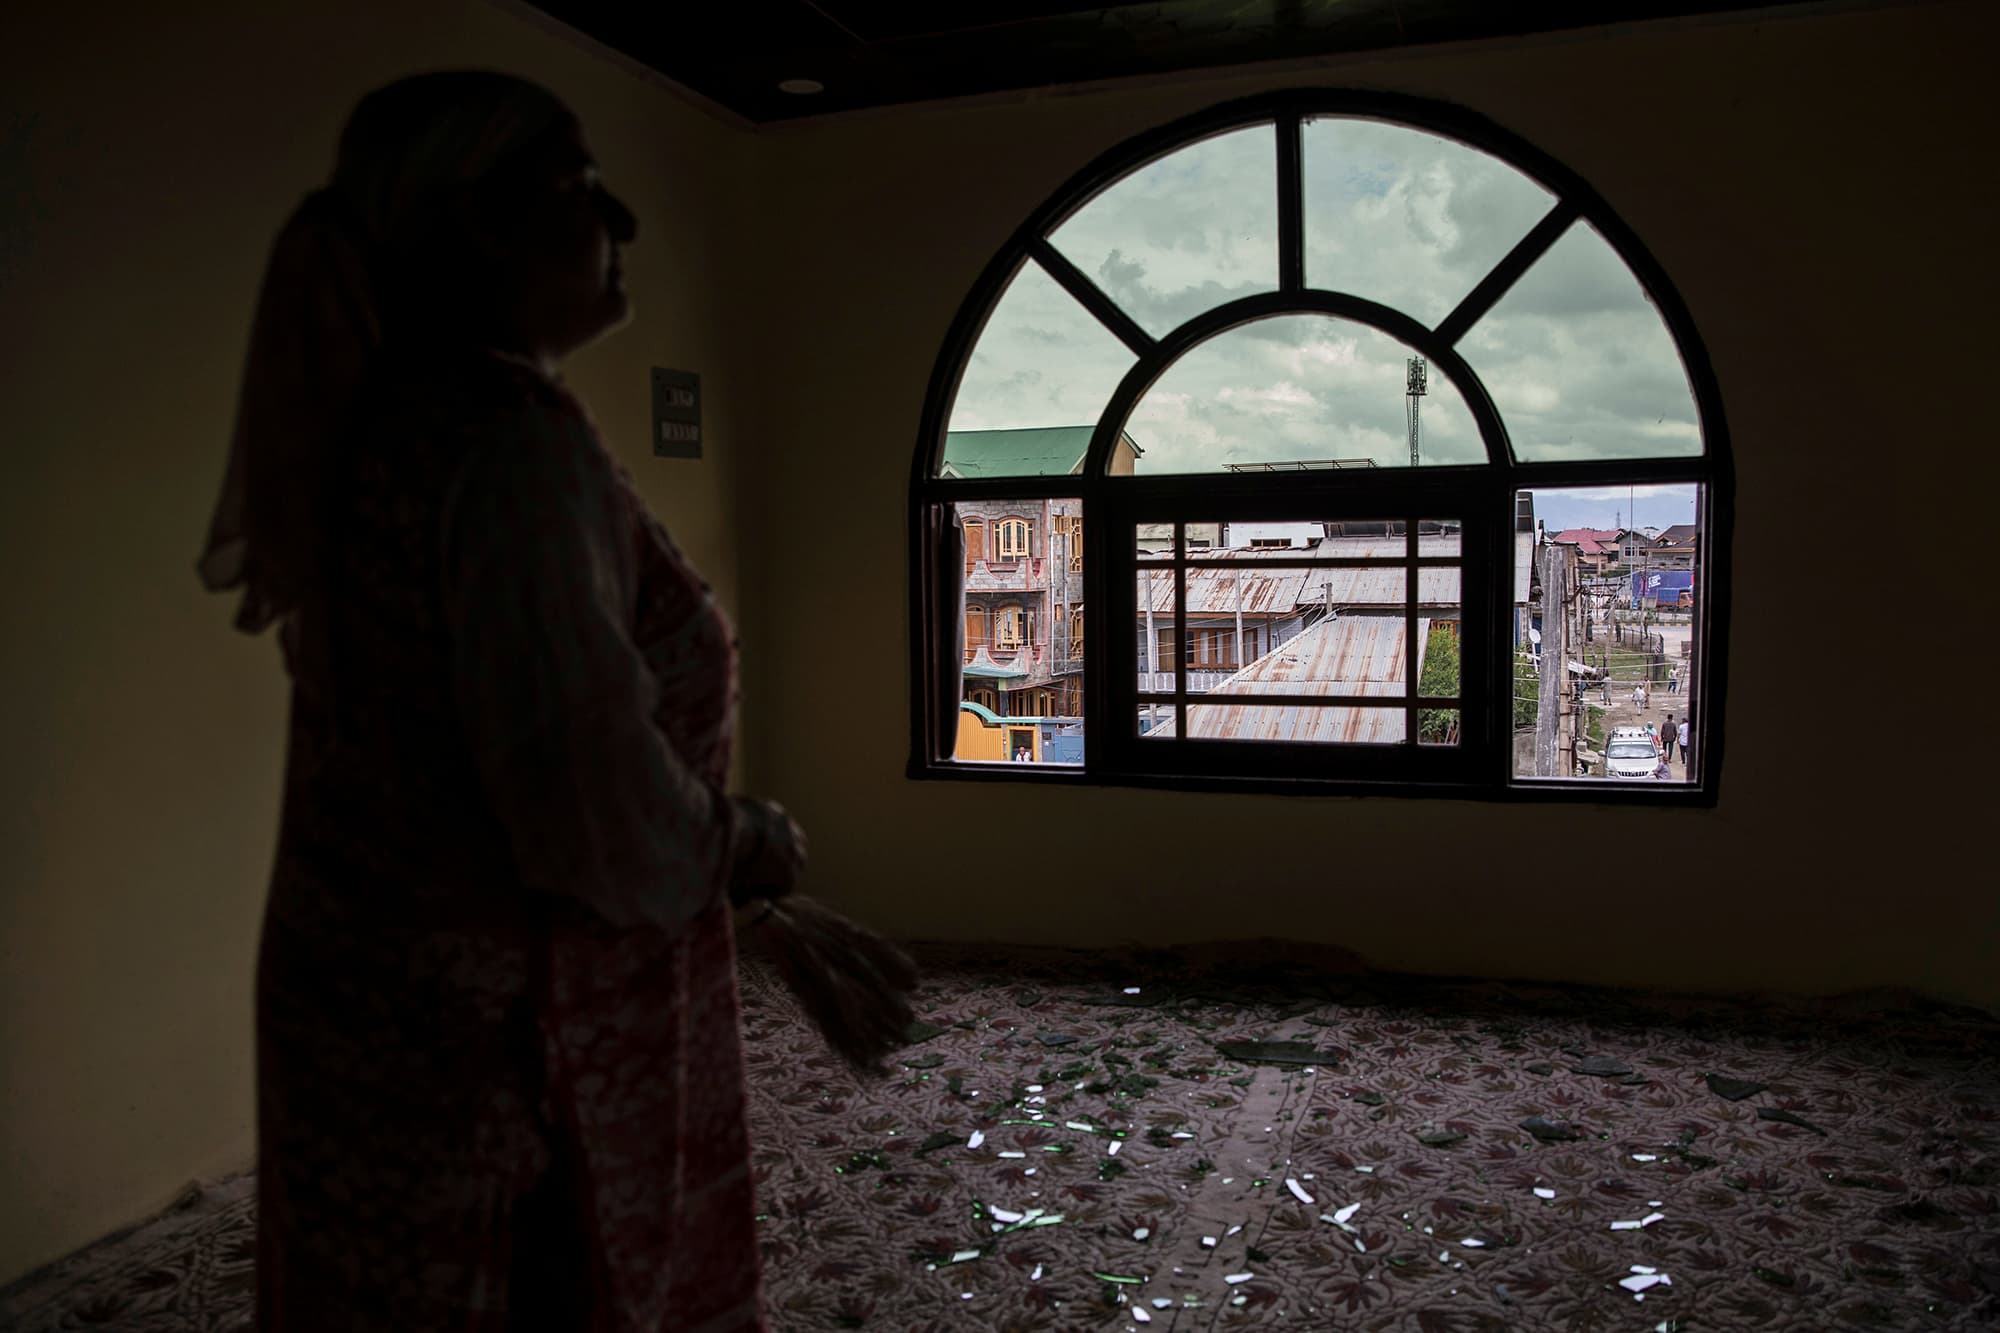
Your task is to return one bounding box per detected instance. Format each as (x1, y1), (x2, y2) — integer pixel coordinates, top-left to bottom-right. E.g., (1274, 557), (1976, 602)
(746, 6), (2000, 1003)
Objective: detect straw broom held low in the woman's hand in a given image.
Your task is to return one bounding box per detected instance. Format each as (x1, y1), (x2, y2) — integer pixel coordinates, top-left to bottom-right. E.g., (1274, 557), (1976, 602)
(756, 893), (916, 1073)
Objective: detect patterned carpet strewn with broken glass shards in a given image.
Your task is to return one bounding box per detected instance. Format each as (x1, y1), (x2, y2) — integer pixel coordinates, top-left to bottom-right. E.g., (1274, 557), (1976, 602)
(0, 947), (2000, 1333)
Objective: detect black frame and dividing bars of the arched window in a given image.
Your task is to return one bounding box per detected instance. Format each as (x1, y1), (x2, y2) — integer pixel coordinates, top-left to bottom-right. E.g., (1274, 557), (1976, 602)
(908, 88), (1734, 807)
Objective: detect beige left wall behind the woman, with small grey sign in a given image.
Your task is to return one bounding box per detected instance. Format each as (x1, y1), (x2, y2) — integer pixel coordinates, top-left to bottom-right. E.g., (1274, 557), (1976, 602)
(0, 0), (748, 1281)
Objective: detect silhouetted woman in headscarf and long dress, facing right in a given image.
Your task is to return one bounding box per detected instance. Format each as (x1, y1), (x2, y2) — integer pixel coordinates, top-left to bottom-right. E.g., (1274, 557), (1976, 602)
(202, 72), (804, 1333)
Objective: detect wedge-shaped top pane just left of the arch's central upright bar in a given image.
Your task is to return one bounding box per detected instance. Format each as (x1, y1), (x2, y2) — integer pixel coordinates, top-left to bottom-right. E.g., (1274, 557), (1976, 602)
(1048, 124), (1278, 338)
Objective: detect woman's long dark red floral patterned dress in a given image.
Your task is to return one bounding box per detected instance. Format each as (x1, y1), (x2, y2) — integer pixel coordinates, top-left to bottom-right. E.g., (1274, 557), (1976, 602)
(256, 344), (764, 1333)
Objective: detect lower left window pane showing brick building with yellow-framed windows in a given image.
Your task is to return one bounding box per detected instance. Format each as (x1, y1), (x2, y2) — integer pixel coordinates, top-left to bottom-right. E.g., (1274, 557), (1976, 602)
(954, 498), (1084, 765)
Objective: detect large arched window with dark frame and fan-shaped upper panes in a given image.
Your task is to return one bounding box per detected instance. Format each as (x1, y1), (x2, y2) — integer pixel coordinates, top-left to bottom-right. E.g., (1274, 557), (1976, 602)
(912, 92), (1732, 803)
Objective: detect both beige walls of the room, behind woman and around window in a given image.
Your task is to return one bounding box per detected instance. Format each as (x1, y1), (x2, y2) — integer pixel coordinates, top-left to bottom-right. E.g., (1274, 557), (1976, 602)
(0, 0), (2000, 1281)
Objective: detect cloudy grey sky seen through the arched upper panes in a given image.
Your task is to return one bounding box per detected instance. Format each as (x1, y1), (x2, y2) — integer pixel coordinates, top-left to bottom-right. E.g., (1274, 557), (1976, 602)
(950, 118), (1700, 474)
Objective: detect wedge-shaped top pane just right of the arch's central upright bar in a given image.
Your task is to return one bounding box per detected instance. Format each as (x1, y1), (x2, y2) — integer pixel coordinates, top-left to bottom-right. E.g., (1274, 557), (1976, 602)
(1300, 118), (1554, 324)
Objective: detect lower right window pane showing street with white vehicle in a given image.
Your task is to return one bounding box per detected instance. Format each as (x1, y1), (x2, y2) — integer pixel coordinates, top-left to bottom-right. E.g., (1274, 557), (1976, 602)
(1512, 484), (1702, 783)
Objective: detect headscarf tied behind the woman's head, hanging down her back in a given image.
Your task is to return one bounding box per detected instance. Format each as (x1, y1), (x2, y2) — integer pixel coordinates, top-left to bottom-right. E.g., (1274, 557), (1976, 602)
(198, 70), (570, 634)
